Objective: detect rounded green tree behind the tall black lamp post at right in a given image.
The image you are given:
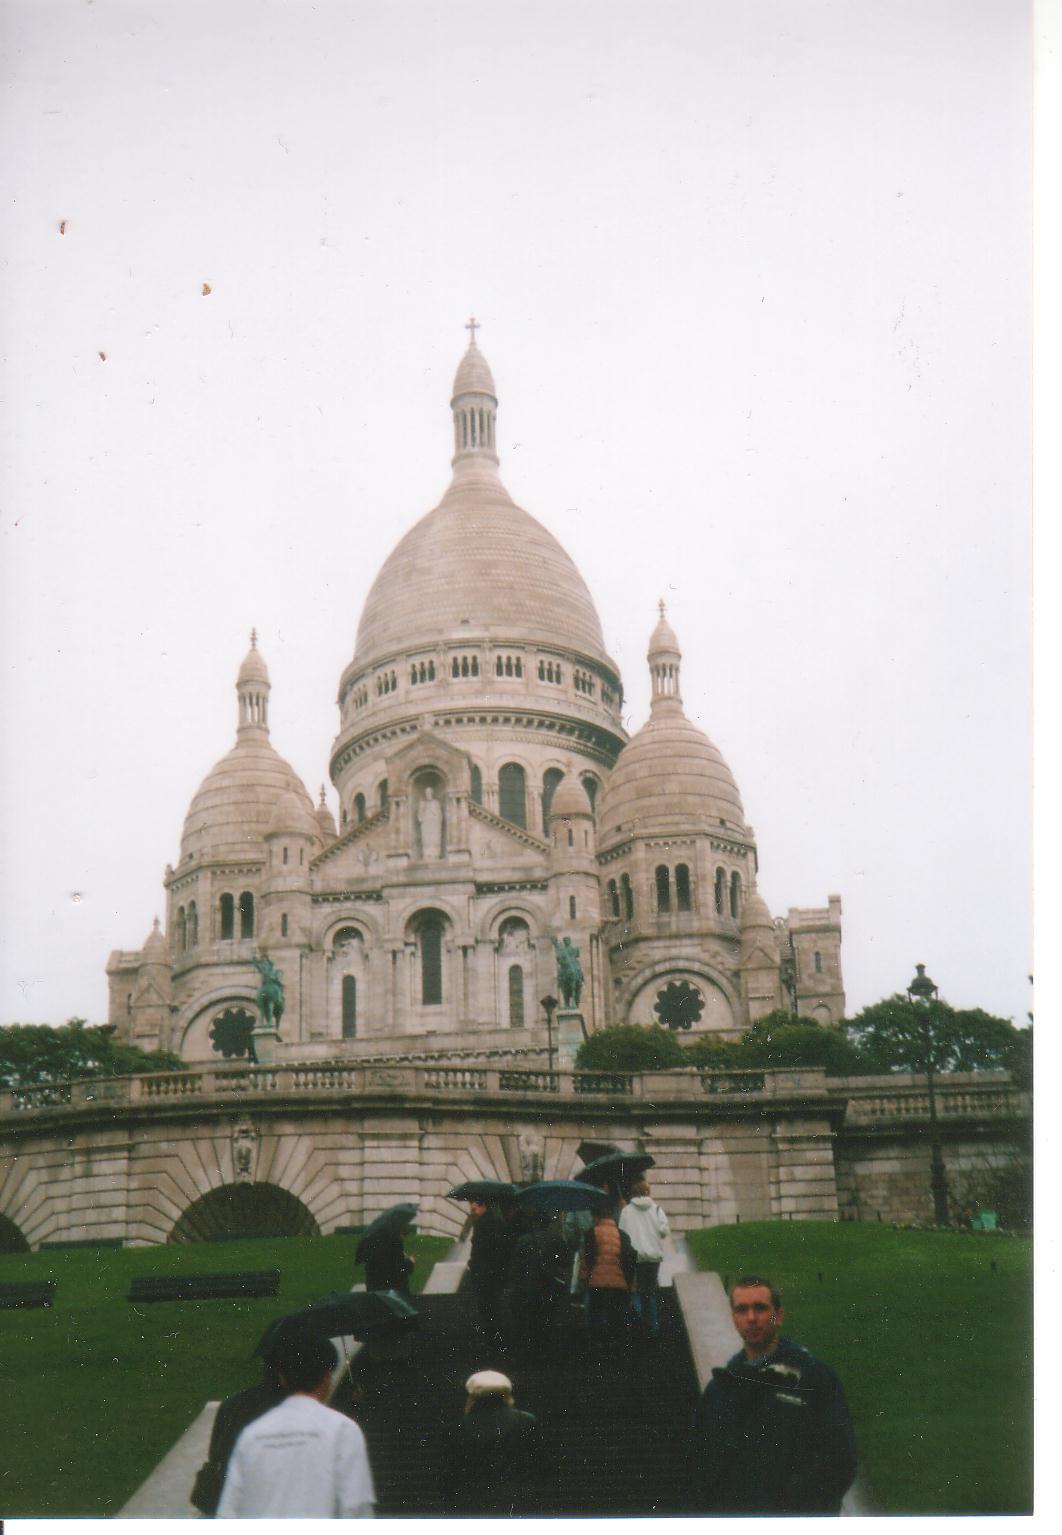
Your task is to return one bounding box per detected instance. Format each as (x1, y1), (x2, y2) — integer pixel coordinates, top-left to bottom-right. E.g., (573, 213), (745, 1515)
(846, 995), (1031, 1071)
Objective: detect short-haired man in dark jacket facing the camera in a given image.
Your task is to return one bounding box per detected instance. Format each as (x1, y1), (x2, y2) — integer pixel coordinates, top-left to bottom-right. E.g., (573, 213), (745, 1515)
(689, 1274), (856, 1514)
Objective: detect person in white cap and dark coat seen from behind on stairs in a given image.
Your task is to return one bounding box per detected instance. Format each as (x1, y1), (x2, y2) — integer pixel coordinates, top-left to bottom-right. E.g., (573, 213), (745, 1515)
(444, 1369), (542, 1518)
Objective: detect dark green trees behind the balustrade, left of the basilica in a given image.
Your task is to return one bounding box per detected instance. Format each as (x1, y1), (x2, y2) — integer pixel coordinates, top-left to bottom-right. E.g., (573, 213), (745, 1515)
(0, 1018), (184, 1088)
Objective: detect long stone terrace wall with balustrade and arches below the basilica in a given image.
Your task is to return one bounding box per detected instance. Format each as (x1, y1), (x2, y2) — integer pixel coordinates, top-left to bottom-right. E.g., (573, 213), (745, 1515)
(0, 1062), (1028, 1246)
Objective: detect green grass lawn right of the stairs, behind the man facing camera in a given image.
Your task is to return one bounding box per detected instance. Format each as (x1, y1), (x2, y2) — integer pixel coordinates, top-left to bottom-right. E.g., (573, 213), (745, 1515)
(689, 1222), (1033, 1514)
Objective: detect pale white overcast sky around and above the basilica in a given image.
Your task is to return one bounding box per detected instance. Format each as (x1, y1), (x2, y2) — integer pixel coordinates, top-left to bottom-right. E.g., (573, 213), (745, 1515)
(0, 0), (1031, 1022)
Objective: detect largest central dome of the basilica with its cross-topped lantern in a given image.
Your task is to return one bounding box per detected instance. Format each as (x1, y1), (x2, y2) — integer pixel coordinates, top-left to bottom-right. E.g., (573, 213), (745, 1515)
(355, 341), (611, 669)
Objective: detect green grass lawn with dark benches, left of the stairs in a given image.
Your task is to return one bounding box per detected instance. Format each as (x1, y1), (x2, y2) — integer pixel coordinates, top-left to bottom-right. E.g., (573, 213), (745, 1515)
(0, 1236), (450, 1518)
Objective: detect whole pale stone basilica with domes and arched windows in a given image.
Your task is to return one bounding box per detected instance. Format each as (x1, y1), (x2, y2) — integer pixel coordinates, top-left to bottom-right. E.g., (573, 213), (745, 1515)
(107, 328), (844, 1062)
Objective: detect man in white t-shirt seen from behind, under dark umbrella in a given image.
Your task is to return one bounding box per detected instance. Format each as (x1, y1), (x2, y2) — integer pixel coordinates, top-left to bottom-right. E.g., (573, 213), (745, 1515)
(216, 1339), (376, 1520)
